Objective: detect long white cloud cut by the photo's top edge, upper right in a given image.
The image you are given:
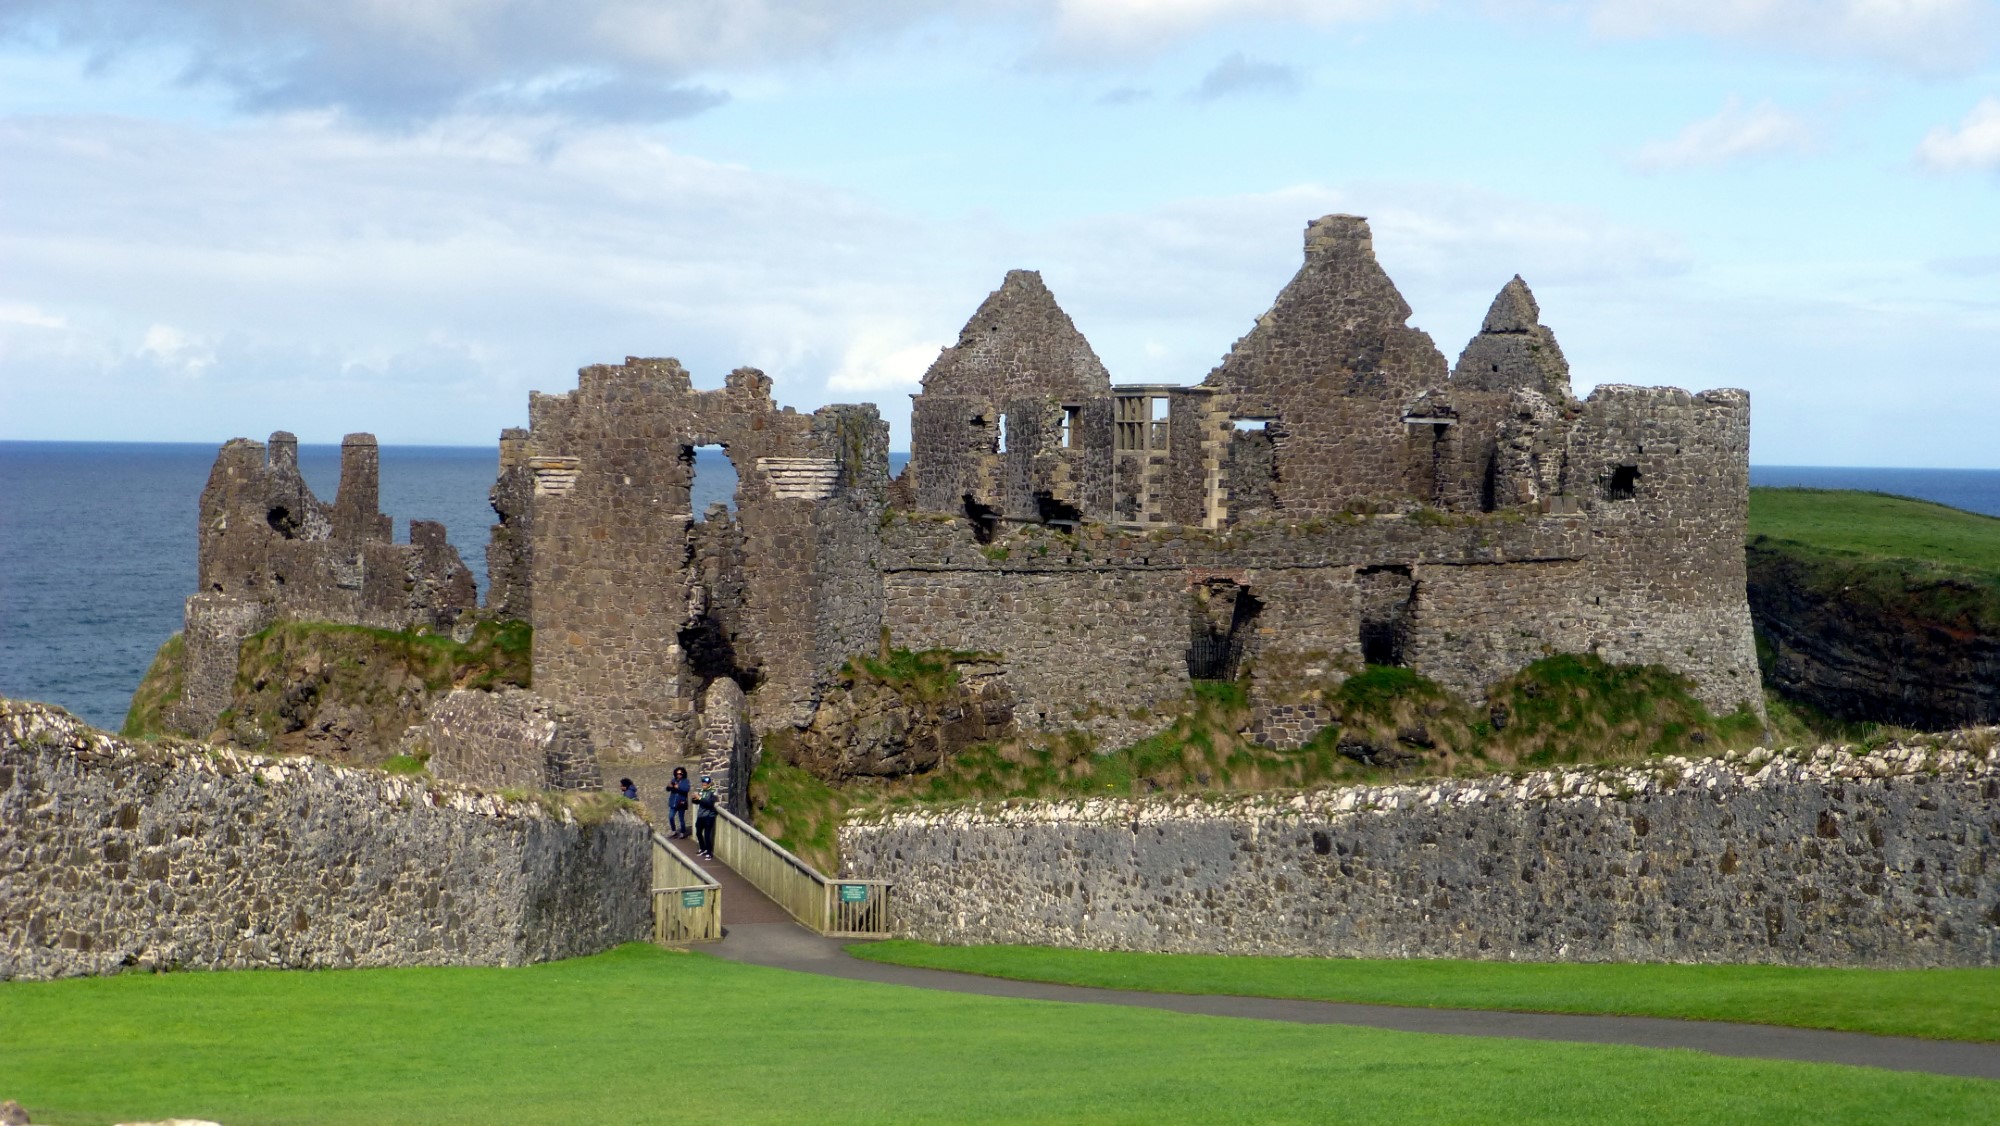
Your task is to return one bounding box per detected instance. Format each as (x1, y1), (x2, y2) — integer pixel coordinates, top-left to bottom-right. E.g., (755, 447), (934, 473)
(1584, 0), (2000, 72)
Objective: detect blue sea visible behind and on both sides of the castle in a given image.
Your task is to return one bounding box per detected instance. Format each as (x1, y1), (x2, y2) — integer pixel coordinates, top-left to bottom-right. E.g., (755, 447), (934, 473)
(0, 442), (2000, 730)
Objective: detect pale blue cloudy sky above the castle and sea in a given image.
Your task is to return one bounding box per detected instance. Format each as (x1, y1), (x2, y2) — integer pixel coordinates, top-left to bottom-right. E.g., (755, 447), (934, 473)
(0, 0), (2000, 468)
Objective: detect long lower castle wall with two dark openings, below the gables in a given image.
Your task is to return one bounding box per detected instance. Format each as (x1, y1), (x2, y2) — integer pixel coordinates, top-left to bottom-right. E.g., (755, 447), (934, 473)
(882, 498), (1758, 742)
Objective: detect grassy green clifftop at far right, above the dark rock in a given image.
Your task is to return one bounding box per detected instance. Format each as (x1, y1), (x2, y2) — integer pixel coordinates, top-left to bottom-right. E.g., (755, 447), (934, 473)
(1750, 488), (2000, 570)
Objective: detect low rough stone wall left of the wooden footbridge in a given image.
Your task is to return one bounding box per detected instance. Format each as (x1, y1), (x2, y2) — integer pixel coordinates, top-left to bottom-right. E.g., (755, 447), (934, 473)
(0, 700), (652, 978)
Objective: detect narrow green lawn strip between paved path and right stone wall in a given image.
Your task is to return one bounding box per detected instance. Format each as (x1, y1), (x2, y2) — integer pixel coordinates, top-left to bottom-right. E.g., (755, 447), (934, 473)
(850, 942), (2000, 1040)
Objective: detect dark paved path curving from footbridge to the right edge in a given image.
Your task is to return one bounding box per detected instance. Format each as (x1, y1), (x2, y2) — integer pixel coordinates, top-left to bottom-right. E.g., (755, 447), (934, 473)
(700, 924), (2000, 1080)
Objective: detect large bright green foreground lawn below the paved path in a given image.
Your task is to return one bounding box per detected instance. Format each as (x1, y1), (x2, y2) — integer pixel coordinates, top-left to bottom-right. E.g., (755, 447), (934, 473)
(0, 946), (2000, 1126)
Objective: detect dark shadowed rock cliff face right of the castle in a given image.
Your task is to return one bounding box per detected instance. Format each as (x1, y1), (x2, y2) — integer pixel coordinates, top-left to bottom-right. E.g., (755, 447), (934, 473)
(1748, 536), (2000, 730)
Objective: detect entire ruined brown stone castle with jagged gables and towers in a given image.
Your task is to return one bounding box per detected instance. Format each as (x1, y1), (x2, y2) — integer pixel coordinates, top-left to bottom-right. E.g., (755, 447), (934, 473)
(178, 216), (1762, 798)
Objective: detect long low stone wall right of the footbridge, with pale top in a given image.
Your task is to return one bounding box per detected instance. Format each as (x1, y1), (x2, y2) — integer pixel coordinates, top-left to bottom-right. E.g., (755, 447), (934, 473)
(840, 748), (2000, 966)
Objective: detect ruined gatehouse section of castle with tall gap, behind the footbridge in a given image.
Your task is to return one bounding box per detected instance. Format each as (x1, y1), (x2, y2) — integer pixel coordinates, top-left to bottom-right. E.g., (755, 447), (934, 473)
(522, 358), (888, 762)
